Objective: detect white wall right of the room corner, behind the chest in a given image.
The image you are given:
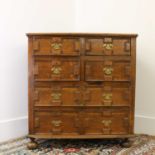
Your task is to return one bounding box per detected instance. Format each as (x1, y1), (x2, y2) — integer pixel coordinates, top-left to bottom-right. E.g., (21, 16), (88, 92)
(75, 0), (155, 135)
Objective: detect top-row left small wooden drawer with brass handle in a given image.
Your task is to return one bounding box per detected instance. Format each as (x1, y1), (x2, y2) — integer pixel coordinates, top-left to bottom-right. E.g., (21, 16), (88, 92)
(33, 37), (80, 56)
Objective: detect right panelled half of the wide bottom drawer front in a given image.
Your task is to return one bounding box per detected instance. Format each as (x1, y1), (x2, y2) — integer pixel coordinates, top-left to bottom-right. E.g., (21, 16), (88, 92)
(84, 109), (129, 135)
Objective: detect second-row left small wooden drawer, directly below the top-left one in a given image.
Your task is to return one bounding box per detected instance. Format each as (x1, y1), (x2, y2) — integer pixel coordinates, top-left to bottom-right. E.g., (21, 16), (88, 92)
(34, 58), (80, 81)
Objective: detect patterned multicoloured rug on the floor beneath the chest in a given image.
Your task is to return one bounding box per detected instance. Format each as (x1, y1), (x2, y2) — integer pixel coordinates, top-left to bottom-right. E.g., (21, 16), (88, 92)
(0, 135), (155, 155)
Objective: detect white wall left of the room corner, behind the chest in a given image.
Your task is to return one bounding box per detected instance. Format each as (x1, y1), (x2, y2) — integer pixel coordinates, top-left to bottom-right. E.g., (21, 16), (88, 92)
(0, 0), (75, 141)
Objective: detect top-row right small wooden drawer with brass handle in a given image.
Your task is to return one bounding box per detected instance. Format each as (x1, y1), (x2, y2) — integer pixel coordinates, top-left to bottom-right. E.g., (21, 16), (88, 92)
(85, 37), (131, 55)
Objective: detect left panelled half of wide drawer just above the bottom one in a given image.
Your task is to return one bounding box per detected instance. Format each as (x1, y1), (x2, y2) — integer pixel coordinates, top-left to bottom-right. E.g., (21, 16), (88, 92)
(34, 87), (80, 106)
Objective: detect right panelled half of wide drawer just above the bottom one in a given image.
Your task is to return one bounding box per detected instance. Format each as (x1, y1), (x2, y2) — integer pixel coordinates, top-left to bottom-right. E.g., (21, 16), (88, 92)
(83, 86), (131, 106)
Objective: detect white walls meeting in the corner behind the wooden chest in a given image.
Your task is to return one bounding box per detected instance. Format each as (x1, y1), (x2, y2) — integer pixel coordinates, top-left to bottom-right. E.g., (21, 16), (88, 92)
(0, 0), (155, 141)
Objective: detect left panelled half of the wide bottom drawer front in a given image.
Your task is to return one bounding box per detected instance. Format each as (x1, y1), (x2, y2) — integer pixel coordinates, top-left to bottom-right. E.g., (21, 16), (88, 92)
(35, 111), (76, 135)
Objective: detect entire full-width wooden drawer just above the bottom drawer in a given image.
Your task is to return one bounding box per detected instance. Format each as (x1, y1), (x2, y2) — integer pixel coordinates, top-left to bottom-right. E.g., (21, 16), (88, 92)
(34, 85), (131, 107)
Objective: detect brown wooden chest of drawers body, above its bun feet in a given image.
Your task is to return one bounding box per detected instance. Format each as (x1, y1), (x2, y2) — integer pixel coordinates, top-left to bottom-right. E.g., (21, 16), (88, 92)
(27, 33), (137, 141)
